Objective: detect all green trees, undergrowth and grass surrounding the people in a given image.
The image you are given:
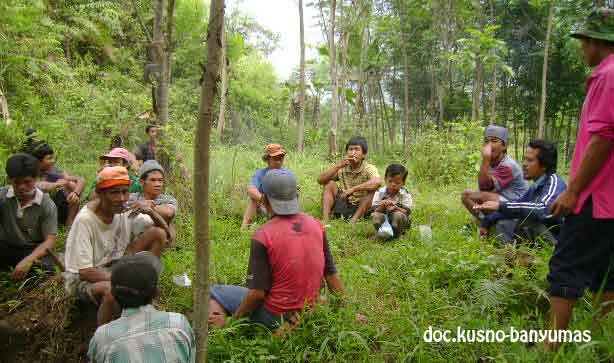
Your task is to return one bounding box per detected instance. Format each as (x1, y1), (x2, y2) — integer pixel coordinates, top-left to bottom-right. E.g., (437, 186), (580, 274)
(0, 0), (614, 362)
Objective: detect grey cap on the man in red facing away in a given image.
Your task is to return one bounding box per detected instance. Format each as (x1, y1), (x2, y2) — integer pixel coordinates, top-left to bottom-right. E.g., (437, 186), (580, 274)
(262, 169), (299, 216)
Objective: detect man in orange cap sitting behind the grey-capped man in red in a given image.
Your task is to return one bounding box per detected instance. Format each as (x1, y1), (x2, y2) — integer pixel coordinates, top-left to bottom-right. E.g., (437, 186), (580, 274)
(241, 144), (286, 230)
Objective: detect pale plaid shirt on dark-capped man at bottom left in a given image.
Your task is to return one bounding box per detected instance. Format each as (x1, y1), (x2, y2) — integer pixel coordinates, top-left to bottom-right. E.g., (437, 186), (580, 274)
(87, 305), (196, 363)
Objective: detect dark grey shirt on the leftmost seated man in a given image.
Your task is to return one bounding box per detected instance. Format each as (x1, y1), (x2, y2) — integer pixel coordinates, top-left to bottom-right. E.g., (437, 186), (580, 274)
(0, 187), (58, 248)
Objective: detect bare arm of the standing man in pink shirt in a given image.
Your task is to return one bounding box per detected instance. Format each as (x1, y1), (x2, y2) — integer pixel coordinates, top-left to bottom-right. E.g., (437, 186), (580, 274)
(550, 134), (614, 216)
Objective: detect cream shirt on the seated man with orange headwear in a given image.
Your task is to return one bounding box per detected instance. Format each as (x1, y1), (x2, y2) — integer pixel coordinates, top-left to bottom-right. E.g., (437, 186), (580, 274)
(65, 205), (153, 274)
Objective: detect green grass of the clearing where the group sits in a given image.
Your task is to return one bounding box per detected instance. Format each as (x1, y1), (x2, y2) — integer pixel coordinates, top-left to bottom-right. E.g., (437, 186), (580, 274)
(4, 141), (614, 362)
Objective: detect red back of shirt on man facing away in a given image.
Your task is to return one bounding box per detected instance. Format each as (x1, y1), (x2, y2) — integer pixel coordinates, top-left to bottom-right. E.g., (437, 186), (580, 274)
(253, 213), (325, 314)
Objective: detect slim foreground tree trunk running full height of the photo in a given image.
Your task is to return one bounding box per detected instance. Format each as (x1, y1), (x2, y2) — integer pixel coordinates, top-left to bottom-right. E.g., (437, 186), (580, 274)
(193, 0), (224, 363)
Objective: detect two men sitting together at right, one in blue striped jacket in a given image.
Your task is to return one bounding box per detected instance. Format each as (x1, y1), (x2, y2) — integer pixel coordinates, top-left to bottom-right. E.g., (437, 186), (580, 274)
(461, 125), (567, 244)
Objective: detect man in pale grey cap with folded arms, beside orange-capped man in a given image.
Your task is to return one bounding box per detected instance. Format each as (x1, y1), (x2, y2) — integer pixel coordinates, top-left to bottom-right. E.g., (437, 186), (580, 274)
(128, 160), (177, 243)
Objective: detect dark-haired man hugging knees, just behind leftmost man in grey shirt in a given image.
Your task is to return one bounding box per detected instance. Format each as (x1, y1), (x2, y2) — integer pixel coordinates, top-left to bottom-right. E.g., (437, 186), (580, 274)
(29, 142), (85, 227)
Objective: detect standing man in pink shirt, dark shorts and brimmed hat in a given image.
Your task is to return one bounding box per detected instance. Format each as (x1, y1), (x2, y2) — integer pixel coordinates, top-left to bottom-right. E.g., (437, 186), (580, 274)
(548, 8), (614, 348)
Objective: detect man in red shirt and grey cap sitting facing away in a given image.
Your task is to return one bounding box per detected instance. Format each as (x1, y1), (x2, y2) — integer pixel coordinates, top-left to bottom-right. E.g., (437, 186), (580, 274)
(209, 169), (343, 328)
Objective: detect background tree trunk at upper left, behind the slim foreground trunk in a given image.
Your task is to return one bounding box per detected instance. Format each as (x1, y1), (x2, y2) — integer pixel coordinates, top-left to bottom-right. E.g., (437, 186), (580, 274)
(152, 0), (168, 125)
